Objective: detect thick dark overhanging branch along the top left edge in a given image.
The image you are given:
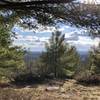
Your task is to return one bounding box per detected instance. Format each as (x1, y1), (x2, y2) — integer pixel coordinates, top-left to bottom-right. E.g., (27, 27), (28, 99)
(0, 0), (74, 9)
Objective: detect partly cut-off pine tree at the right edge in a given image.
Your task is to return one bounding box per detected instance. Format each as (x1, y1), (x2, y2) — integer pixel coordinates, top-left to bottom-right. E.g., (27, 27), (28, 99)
(76, 45), (100, 84)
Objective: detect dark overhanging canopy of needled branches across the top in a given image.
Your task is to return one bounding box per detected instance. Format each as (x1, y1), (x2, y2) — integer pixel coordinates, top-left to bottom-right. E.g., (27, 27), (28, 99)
(0, 0), (100, 33)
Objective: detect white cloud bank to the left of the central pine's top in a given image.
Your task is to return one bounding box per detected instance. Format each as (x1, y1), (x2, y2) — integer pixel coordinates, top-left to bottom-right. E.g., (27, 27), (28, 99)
(13, 35), (49, 50)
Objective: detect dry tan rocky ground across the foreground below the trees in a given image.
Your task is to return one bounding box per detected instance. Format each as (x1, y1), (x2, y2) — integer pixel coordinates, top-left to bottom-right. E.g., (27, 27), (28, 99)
(0, 80), (100, 100)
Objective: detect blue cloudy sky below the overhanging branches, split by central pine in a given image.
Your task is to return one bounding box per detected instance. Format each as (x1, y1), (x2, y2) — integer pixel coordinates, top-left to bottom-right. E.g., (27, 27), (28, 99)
(13, 23), (100, 52)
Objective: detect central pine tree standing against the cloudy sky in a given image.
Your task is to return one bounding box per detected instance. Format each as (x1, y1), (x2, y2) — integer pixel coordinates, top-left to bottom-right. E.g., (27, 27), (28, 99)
(42, 31), (79, 78)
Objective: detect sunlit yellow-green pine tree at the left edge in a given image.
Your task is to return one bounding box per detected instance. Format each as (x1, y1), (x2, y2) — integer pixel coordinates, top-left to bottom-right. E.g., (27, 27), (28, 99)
(0, 25), (24, 80)
